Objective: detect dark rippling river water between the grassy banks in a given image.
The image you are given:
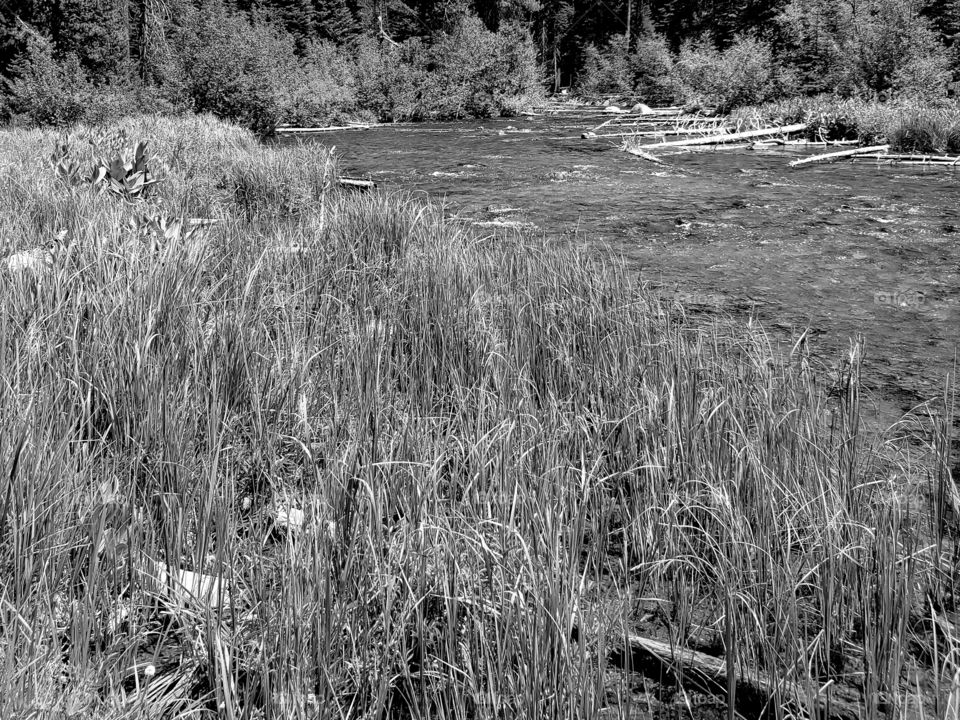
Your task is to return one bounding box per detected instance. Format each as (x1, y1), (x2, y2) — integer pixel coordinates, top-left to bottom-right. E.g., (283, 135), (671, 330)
(296, 117), (960, 418)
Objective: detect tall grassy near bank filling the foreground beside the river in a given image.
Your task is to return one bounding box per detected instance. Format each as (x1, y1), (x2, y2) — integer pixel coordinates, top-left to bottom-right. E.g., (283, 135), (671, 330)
(0, 118), (960, 718)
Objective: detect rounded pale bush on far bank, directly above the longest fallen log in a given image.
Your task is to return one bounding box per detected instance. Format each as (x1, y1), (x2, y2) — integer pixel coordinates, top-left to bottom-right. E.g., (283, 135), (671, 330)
(676, 37), (789, 113)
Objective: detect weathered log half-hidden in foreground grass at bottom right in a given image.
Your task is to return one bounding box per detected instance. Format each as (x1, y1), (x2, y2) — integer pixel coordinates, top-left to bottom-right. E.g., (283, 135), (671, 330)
(627, 635), (861, 720)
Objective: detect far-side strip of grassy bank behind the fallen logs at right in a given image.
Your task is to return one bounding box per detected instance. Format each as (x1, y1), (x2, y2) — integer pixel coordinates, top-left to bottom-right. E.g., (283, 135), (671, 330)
(732, 96), (960, 155)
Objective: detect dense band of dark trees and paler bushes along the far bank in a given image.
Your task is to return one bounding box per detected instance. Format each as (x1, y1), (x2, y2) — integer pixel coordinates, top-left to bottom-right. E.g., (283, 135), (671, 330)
(0, 0), (960, 130)
